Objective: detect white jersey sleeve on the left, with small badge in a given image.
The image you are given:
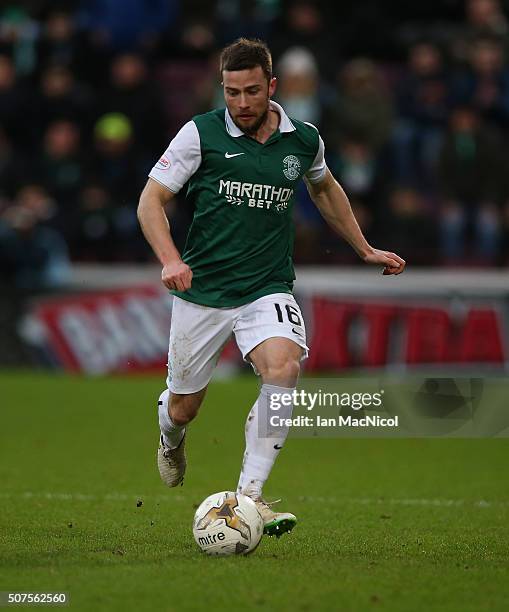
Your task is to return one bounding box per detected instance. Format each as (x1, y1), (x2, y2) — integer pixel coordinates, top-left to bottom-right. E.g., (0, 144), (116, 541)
(149, 121), (201, 193)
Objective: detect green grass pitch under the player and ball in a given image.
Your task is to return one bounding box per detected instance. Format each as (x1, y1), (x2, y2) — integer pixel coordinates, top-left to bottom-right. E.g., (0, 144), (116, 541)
(0, 374), (509, 612)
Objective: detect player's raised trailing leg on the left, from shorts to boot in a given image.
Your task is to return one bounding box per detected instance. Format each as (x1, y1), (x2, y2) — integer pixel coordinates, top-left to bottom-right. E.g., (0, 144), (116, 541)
(157, 298), (232, 487)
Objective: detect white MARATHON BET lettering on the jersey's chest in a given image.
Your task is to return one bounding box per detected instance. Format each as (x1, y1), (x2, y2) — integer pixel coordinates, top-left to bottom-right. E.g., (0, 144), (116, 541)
(219, 180), (293, 212)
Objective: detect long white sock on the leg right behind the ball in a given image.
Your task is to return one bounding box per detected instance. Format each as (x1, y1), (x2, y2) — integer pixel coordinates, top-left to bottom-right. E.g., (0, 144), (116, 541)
(237, 384), (294, 499)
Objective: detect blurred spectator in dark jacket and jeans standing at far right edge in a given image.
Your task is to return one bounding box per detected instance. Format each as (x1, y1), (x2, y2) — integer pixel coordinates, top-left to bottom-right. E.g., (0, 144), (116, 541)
(438, 107), (506, 265)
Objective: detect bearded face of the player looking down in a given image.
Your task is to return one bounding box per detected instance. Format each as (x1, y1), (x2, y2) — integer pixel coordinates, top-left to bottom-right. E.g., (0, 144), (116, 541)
(223, 66), (276, 134)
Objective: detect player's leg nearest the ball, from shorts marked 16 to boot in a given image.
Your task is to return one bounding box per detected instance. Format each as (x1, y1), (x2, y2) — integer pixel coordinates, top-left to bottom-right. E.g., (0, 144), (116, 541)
(234, 294), (308, 535)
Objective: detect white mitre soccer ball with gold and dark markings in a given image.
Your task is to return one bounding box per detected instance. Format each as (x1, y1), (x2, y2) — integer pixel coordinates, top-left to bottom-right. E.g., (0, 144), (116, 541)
(193, 491), (263, 555)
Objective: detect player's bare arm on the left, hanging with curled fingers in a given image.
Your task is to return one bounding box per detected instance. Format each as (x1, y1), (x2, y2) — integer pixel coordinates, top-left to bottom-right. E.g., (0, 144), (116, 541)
(138, 178), (193, 291)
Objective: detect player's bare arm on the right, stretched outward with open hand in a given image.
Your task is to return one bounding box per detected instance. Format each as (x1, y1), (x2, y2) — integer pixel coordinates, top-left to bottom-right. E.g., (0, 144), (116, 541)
(306, 168), (405, 274)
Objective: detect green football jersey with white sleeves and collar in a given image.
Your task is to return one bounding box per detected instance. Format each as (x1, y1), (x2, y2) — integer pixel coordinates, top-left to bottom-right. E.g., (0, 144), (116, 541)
(149, 102), (326, 308)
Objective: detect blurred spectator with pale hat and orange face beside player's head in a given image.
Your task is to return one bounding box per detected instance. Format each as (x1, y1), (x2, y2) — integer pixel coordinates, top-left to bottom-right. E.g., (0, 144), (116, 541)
(276, 47), (322, 127)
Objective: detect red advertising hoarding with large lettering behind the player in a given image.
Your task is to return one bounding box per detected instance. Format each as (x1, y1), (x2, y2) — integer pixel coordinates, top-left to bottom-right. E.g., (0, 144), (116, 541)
(24, 284), (508, 374)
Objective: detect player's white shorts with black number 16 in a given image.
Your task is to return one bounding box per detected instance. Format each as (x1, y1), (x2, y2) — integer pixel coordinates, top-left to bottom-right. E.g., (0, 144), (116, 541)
(166, 293), (309, 393)
